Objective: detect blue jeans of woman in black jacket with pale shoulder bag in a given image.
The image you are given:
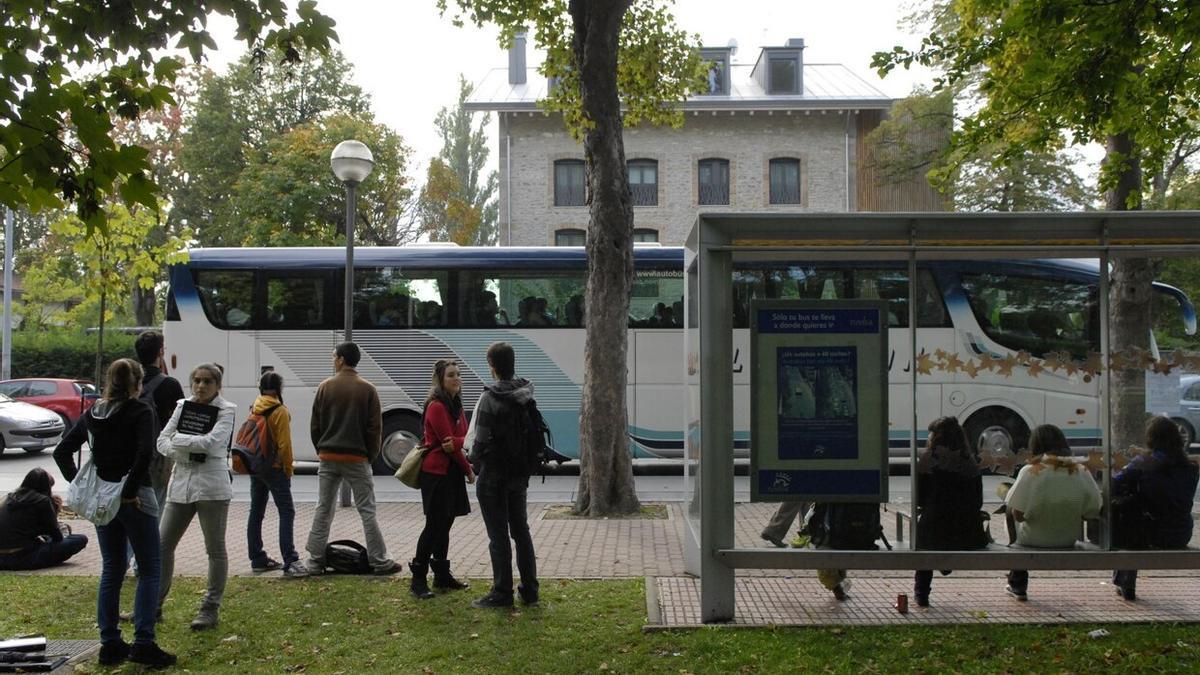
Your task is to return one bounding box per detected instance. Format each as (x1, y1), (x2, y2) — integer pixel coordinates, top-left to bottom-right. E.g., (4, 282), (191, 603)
(96, 488), (160, 644)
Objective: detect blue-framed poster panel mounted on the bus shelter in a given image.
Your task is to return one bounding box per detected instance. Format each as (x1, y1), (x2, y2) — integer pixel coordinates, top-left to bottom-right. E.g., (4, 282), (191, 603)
(750, 300), (888, 502)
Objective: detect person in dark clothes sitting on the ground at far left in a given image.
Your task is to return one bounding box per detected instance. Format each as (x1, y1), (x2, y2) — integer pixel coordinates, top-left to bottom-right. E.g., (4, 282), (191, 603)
(0, 468), (88, 569)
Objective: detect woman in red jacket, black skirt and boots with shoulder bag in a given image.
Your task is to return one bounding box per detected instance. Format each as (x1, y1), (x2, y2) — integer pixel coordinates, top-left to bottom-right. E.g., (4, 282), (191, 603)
(409, 359), (475, 599)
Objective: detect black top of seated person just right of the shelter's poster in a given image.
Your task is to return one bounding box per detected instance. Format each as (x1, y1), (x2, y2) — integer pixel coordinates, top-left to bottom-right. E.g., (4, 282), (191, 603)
(917, 447), (988, 551)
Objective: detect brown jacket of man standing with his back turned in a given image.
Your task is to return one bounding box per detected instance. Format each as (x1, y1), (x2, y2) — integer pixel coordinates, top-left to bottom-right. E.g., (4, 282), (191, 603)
(310, 368), (383, 461)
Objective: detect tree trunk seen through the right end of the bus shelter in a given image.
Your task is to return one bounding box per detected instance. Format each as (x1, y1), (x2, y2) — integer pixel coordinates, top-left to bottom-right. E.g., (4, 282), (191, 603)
(1104, 133), (1154, 452)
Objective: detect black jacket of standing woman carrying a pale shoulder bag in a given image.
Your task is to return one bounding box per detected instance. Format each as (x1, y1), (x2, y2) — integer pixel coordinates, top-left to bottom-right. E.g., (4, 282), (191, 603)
(54, 399), (157, 498)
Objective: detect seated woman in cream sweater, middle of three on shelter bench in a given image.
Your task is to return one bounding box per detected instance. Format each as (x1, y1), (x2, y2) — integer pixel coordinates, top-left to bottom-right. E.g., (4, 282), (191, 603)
(1004, 424), (1100, 601)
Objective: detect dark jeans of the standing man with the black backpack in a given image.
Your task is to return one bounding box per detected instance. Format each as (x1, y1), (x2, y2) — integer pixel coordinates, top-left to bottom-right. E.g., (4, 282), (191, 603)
(475, 483), (538, 596)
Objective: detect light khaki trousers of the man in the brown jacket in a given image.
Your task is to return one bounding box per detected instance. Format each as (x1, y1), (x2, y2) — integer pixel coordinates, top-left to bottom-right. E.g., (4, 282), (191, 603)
(305, 460), (391, 569)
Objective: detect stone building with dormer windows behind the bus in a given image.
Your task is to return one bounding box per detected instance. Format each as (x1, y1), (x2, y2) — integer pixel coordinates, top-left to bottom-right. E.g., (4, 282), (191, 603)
(467, 36), (940, 246)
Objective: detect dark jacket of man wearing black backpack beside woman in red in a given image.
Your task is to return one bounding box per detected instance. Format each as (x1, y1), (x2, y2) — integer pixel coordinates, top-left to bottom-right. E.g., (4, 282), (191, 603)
(467, 377), (533, 489)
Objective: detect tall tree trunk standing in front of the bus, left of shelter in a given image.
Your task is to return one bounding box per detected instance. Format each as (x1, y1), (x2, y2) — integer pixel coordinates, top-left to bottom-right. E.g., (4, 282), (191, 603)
(570, 0), (640, 516)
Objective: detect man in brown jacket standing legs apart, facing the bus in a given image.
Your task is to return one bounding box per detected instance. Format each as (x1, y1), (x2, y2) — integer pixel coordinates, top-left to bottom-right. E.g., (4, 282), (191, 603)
(306, 342), (402, 574)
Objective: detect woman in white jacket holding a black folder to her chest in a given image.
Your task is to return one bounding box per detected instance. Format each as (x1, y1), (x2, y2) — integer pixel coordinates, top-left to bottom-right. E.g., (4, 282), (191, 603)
(158, 363), (238, 631)
